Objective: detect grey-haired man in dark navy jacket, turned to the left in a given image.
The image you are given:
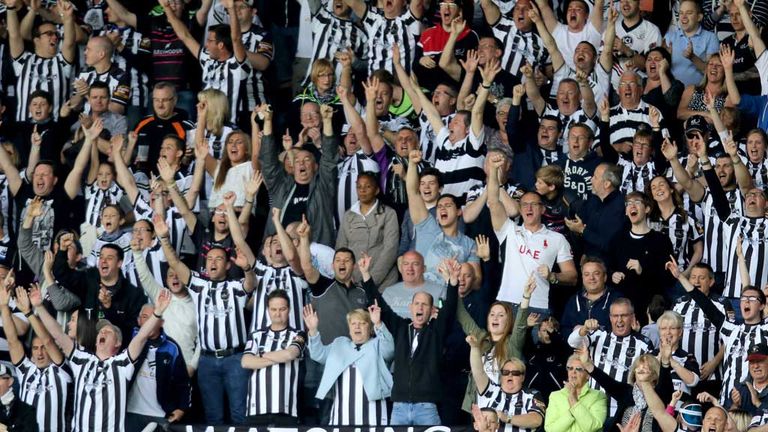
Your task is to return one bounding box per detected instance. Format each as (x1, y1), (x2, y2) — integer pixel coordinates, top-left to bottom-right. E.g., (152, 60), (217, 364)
(565, 163), (626, 261)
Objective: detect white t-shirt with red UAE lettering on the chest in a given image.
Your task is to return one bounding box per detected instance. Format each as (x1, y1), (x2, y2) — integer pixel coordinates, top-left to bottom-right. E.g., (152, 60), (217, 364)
(496, 220), (573, 309)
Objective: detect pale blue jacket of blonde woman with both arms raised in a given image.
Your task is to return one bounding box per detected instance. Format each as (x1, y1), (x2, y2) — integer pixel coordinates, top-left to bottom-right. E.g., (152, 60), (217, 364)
(309, 324), (395, 401)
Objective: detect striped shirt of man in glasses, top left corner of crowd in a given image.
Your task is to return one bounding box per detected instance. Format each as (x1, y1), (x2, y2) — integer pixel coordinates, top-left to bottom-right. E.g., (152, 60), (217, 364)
(13, 52), (73, 122)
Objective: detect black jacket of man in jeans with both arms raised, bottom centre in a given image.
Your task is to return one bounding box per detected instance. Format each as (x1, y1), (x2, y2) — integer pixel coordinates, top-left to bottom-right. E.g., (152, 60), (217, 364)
(363, 280), (458, 403)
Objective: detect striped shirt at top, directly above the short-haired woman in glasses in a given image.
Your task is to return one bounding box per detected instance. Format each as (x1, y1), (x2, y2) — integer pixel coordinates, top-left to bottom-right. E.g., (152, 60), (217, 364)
(302, 2), (368, 87)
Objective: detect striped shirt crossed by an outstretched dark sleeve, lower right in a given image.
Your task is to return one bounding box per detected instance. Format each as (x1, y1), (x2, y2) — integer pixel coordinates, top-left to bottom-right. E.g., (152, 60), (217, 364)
(672, 295), (727, 380)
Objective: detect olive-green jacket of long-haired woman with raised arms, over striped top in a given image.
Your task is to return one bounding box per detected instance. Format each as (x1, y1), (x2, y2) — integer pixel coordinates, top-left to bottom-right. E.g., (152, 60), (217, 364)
(456, 299), (530, 412)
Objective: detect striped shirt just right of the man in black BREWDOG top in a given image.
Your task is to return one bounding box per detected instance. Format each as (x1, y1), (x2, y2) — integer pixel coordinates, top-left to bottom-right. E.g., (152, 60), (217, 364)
(198, 47), (251, 122)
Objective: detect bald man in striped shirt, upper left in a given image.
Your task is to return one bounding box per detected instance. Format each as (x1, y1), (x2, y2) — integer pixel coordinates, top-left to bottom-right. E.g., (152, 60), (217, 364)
(72, 36), (131, 114)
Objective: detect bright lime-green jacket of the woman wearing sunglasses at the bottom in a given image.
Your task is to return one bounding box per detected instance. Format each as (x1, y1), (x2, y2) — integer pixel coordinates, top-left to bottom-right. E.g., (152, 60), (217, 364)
(544, 383), (608, 432)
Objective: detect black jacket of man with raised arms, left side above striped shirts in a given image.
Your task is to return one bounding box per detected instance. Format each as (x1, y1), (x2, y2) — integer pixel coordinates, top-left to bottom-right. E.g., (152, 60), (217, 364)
(53, 251), (147, 348)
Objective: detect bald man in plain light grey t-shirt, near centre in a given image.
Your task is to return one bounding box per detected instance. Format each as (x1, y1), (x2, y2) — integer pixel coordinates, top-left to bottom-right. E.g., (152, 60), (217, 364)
(381, 250), (445, 318)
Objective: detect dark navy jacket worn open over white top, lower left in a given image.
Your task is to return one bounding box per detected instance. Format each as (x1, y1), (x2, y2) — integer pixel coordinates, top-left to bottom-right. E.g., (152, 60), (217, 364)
(129, 328), (192, 415)
